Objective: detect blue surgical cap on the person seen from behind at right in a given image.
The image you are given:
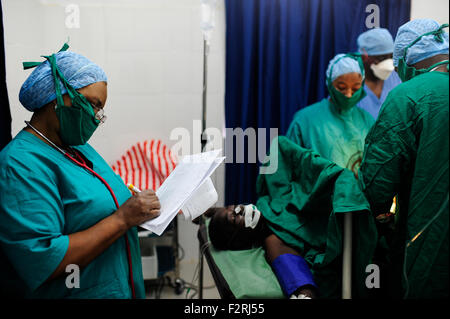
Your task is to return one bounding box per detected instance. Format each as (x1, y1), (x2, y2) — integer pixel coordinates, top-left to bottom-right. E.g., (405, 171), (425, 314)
(393, 19), (448, 66)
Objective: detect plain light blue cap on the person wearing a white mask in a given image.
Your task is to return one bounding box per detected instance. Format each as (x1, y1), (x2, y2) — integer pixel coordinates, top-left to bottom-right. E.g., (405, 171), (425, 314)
(356, 28), (394, 55)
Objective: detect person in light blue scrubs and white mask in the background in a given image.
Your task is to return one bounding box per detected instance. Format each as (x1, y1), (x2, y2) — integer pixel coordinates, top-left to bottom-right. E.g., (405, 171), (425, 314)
(357, 28), (401, 119)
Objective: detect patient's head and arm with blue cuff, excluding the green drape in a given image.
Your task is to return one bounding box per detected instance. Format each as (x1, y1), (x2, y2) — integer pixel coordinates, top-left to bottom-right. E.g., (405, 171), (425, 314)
(205, 205), (317, 299)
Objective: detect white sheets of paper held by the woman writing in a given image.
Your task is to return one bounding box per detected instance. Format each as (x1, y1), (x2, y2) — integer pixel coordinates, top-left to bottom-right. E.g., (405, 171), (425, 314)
(140, 150), (225, 236)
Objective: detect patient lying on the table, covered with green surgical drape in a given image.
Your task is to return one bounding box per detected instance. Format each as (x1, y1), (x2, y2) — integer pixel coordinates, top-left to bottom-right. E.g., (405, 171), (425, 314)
(205, 136), (378, 299)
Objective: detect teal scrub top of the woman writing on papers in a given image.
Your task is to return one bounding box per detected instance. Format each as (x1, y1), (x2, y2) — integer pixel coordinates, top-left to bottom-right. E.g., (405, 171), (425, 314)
(0, 130), (145, 299)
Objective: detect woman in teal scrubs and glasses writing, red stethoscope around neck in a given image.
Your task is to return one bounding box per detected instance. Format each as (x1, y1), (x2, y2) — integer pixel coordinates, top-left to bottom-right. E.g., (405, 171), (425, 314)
(0, 46), (160, 298)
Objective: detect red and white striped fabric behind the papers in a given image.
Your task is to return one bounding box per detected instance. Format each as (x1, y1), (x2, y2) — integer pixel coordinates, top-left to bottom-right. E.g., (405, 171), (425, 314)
(112, 140), (176, 191)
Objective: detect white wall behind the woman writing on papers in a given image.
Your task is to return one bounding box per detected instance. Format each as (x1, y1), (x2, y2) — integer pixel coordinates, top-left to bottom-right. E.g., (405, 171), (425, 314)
(2, 0), (225, 260)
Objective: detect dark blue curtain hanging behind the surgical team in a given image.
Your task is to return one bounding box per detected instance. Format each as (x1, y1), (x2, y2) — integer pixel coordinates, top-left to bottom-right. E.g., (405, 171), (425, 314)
(225, 0), (410, 205)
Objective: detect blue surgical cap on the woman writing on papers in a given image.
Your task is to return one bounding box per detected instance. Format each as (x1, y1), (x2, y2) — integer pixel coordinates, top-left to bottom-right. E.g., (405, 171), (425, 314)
(19, 51), (107, 112)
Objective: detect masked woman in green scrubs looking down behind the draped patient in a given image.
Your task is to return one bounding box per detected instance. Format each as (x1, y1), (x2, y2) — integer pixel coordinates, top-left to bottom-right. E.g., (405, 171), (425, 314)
(286, 54), (374, 174)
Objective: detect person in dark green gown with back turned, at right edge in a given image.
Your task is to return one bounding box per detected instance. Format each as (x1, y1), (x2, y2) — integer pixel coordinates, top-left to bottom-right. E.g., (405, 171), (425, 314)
(359, 19), (449, 298)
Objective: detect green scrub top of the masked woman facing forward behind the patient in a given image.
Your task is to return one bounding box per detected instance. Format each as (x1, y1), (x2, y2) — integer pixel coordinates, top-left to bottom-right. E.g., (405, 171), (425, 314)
(286, 99), (375, 173)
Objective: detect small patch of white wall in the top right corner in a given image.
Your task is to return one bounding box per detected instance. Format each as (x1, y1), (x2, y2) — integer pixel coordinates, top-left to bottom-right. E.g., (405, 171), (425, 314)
(411, 0), (449, 24)
